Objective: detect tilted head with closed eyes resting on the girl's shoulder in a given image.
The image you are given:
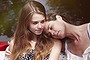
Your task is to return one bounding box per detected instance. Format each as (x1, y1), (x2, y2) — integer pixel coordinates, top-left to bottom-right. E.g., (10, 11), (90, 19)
(44, 14), (65, 39)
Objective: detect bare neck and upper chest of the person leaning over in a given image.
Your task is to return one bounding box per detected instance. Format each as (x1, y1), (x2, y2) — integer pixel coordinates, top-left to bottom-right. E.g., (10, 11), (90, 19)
(67, 24), (90, 56)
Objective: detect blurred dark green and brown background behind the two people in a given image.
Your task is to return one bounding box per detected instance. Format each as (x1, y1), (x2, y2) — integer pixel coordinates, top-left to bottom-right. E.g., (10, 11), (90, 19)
(0, 0), (90, 41)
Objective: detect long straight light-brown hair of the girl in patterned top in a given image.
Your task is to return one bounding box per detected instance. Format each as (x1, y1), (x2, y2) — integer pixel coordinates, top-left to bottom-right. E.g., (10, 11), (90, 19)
(11, 1), (53, 60)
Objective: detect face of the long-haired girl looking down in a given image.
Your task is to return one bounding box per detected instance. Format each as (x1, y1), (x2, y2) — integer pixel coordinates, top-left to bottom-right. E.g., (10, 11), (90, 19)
(29, 13), (45, 35)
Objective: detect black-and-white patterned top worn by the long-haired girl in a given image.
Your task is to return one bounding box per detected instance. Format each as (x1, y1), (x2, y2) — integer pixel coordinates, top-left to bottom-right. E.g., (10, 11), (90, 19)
(19, 49), (50, 60)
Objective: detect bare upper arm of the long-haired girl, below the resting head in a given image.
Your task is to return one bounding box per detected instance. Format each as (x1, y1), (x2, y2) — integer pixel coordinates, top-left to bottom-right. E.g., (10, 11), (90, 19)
(49, 40), (62, 60)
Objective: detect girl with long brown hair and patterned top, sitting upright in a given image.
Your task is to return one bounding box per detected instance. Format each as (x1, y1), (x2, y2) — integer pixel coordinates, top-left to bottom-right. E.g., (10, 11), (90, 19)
(6, 1), (61, 60)
